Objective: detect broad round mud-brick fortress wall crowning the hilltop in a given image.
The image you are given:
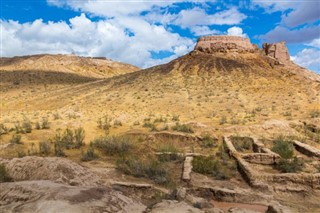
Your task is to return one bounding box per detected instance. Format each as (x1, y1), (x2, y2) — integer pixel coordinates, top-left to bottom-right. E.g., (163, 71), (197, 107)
(195, 36), (258, 52)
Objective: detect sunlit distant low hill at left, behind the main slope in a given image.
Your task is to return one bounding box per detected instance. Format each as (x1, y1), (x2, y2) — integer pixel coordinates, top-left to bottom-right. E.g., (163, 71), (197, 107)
(0, 54), (139, 83)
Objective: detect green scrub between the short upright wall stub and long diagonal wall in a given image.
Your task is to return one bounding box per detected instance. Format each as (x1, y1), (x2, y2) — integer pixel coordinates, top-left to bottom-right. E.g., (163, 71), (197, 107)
(192, 156), (236, 180)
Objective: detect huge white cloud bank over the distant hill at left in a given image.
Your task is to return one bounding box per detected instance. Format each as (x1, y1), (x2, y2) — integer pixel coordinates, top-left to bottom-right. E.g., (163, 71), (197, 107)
(0, 14), (194, 67)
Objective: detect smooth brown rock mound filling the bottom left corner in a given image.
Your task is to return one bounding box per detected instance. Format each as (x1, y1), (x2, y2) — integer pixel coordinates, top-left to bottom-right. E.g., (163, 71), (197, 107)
(0, 180), (146, 213)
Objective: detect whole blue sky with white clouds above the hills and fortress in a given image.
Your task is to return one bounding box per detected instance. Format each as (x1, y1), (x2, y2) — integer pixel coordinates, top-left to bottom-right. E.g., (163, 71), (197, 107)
(1, 0), (320, 73)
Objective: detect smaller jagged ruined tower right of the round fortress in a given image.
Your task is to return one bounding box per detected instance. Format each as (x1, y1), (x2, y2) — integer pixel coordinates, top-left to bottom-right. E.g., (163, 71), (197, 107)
(262, 41), (290, 64)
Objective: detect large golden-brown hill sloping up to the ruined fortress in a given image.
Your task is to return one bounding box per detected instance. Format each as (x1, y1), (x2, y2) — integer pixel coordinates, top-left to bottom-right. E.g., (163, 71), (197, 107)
(3, 37), (320, 128)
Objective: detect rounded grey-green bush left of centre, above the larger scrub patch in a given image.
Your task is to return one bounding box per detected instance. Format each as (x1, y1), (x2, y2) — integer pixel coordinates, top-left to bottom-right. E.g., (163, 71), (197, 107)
(93, 136), (134, 155)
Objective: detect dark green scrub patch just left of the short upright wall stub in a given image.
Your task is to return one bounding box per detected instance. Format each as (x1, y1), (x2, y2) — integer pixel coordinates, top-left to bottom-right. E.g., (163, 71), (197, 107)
(116, 156), (171, 185)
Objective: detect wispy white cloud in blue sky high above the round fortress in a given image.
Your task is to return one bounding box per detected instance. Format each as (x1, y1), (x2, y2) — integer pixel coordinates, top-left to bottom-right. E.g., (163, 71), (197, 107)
(174, 7), (247, 28)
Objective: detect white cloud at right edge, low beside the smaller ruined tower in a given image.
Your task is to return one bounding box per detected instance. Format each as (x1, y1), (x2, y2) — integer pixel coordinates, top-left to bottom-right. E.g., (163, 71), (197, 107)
(291, 48), (320, 70)
